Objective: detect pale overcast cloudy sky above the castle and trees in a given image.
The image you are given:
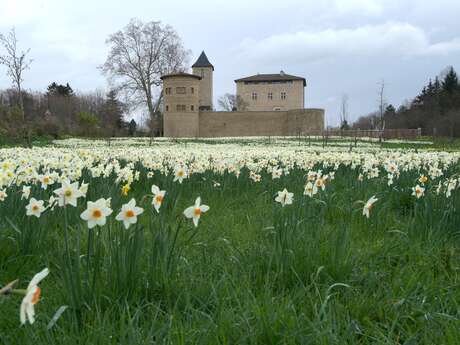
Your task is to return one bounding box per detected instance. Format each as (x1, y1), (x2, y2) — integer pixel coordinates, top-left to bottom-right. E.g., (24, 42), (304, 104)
(0, 0), (460, 124)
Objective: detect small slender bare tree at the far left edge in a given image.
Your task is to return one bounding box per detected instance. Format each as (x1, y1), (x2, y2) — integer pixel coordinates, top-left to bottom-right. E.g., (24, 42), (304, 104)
(0, 28), (32, 121)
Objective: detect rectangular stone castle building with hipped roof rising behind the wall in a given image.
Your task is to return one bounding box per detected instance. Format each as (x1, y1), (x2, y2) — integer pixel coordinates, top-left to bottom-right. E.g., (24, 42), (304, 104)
(235, 71), (307, 111)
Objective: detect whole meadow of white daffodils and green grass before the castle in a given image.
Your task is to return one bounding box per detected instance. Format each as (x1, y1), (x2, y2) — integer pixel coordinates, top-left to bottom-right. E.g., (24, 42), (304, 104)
(0, 138), (460, 345)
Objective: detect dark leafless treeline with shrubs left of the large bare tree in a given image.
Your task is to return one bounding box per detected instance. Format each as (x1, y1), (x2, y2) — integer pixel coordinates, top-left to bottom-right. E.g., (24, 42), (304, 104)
(0, 82), (137, 142)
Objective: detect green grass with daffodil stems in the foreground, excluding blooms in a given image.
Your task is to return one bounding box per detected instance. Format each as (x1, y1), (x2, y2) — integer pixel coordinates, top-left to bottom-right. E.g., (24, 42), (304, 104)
(0, 160), (460, 345)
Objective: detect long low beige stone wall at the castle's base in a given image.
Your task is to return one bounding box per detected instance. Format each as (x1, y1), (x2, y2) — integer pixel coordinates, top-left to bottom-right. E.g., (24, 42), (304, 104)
(164, 109), (324, 138)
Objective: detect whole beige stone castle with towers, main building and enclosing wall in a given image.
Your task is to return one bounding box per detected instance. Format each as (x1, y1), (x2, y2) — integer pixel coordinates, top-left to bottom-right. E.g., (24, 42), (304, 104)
(161, 52), (324, 137)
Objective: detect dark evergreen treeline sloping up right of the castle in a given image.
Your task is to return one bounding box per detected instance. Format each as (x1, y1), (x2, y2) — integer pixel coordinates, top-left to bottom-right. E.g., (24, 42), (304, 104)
(353, 67), (460, 137)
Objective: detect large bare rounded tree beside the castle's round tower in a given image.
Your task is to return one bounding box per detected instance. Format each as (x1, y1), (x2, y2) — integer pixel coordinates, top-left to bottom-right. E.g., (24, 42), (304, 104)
(100, 19), (190, 132)
